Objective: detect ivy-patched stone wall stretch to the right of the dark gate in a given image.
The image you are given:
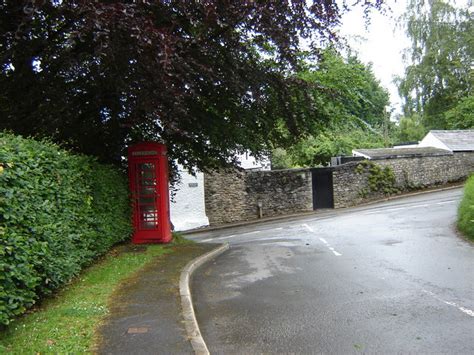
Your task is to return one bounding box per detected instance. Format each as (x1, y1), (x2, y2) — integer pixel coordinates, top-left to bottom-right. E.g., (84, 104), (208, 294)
(333, 153), (474, 208)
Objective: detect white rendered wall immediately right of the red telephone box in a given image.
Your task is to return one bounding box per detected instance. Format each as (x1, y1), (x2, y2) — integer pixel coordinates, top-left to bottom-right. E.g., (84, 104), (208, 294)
(170, 168), (209, 231)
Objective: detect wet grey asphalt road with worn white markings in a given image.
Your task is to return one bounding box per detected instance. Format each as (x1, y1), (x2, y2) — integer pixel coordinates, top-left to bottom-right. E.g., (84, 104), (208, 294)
(192, 189), (474, 354)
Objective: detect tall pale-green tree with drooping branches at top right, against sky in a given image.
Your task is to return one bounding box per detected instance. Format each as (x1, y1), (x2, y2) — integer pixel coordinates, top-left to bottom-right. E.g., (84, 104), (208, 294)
(399, 0), (474, 129)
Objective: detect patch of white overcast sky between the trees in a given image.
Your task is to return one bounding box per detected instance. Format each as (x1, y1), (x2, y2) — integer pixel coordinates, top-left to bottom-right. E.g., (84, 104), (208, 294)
(340, 0), (410, 117)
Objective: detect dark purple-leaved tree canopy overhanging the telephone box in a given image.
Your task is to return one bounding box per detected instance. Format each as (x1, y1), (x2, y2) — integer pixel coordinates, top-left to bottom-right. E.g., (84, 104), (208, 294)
(0, 0), (383, 168)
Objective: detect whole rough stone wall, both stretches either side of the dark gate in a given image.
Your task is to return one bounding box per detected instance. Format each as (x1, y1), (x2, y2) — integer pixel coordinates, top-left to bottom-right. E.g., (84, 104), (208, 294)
(204, 153), (474, 225)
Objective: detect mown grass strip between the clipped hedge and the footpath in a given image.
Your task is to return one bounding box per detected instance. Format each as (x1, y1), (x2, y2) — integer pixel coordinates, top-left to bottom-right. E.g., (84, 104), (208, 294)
(0, 236), (189, 354)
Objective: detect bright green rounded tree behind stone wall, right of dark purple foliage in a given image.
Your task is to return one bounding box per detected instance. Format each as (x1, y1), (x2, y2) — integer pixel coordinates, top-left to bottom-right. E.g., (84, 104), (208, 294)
(272, 49), (389, 168)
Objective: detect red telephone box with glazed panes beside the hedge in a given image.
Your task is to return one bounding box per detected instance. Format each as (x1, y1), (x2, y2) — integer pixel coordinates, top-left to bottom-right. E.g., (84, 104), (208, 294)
(128, 142), (171, 244)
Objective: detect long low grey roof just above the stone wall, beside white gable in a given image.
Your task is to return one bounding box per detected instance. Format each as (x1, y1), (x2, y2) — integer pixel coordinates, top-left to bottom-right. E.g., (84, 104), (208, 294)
(352, 147), (453, 159)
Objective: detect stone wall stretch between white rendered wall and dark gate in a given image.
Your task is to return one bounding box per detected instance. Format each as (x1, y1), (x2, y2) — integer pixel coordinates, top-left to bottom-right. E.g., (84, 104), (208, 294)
(204, 169), (313, 225)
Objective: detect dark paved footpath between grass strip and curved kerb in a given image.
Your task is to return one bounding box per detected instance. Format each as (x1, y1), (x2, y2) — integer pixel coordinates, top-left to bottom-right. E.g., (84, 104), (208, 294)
(97, 244), (215, 354)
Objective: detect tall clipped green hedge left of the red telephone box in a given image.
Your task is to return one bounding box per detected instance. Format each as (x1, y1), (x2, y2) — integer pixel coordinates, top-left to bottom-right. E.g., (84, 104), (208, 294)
(0, 133), (131, 325)
